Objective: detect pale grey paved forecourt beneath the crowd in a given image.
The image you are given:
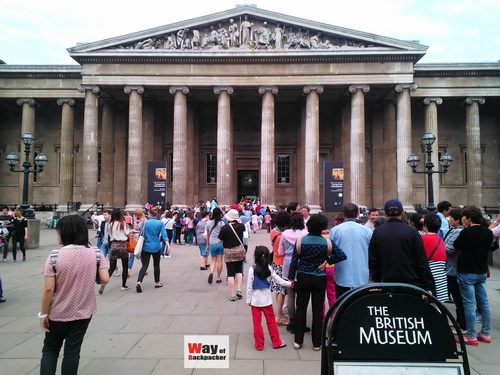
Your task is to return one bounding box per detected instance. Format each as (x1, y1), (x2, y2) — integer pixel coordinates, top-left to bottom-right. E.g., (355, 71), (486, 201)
(0, 228), (500, 375)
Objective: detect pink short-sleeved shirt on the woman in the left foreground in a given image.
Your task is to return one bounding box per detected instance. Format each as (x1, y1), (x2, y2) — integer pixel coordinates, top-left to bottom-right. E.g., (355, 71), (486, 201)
(42, 245), (109, 322)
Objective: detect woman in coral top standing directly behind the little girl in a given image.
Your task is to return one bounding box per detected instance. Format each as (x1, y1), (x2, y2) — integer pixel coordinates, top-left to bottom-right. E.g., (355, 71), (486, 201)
(271, 211), (290, 326)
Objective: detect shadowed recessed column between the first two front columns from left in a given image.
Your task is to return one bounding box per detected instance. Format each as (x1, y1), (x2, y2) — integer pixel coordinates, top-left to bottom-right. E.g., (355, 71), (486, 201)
(99, 101), (113, 209)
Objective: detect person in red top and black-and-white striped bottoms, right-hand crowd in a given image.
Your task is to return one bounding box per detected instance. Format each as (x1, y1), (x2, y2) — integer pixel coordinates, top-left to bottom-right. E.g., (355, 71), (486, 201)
(422, 213), (448, 302)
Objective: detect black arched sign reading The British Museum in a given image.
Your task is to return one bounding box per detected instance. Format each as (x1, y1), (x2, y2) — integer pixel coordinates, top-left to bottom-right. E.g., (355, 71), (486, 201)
(321, 283), (470, 375)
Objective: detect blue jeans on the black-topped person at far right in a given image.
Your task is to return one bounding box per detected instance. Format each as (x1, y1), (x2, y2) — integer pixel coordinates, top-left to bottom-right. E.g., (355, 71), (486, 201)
(457, 272), (491, 338)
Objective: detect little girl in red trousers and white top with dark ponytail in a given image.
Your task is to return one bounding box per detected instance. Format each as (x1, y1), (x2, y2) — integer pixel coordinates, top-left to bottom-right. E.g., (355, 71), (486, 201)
(247, 246), (293, 351)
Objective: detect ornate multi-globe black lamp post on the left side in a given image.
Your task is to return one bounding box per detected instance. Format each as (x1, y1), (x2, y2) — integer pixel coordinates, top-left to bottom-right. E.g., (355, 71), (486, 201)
(5, 133), (48, 219)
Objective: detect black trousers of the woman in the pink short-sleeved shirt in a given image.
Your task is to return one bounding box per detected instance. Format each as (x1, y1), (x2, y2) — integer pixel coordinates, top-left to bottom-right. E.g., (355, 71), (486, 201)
(40, 318), (92, 375)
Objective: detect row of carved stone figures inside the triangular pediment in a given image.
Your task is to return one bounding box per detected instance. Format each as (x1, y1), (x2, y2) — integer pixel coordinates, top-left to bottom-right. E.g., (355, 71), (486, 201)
(107, 15), (377, 51)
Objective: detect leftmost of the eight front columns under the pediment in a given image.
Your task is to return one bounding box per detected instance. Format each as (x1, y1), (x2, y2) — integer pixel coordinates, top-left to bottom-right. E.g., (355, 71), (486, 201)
(78, 86), (99, 211)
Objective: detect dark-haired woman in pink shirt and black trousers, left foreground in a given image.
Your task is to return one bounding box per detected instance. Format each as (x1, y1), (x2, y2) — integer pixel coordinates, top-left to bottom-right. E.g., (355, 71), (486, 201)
(38, 215), (109, 374)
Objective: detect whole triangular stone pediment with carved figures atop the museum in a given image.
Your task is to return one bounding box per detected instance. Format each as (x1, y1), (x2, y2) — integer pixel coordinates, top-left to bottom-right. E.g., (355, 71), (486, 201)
(68, 7), (427, 62)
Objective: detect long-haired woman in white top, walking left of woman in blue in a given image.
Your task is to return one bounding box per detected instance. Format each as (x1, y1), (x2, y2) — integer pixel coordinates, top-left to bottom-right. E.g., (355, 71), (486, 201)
(99, 208), (130, 294)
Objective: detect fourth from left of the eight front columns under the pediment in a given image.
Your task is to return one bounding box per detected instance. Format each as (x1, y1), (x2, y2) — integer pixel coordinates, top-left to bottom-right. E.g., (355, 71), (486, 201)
(214, 87), (236, 207)
